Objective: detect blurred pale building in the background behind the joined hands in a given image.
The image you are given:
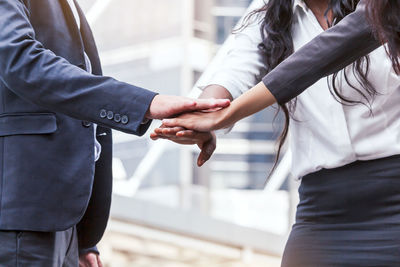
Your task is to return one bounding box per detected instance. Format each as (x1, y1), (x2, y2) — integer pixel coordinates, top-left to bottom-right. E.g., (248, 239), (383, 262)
(79, 0), (296, 267)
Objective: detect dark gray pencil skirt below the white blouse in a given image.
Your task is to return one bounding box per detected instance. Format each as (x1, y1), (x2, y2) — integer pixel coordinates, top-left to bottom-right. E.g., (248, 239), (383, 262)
(282, 155), (400, 267)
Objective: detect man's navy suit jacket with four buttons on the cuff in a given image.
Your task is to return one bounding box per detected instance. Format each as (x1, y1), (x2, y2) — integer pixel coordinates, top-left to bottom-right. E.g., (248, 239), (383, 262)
(0, 0), (155, 247)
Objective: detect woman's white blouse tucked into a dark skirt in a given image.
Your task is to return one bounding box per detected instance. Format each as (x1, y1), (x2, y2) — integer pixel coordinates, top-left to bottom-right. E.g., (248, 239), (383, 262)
(205, 0), (400, 181)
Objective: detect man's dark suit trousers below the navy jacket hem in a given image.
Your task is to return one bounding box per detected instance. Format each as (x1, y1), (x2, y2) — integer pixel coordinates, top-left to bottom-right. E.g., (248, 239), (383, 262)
(0, 227), (79, 267)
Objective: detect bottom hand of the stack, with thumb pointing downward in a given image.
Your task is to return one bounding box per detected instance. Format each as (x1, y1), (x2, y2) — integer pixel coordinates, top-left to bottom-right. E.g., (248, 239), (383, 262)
(150, 125), (217, 167)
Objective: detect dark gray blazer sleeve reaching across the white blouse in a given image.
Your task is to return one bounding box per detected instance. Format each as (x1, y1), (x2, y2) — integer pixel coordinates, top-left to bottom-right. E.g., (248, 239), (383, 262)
(263, 1), (381, 104)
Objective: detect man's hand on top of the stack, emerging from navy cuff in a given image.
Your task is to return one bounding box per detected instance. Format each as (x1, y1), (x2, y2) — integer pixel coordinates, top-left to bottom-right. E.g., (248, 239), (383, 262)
(146, 95), (230, 119)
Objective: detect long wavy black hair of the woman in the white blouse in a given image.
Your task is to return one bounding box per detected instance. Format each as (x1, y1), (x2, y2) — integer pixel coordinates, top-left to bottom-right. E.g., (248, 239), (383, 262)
(239, 0), (381, 178)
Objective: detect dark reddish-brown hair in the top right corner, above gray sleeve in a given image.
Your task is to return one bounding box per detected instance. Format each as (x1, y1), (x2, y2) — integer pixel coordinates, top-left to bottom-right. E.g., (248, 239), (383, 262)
(367, 0), (400, 75)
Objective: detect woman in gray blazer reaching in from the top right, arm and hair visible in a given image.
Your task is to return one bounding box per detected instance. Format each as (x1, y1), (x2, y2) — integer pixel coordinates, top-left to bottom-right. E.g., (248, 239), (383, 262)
(159, 0), (400, 123)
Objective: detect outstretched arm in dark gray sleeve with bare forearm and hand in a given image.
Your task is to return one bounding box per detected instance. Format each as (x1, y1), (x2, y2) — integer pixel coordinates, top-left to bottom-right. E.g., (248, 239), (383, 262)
(163, 1), (381, 131)
